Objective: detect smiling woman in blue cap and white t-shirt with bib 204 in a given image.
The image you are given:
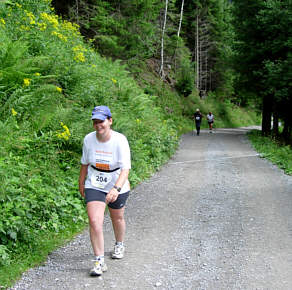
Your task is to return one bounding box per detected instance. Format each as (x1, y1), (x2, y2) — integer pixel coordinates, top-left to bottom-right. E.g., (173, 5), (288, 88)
(79, 106), (131, 276)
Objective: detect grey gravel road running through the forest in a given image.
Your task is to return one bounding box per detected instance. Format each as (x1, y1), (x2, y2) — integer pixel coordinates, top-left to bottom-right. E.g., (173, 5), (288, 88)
(11, 128), (292, 290)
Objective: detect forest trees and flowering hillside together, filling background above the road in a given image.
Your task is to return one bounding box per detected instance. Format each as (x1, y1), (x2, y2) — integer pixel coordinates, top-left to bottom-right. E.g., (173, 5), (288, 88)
(0, 0), (292, 286)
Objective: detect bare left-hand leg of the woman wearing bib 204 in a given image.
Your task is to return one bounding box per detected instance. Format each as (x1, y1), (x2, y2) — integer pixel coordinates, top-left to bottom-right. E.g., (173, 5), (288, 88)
(87, 201), (106, 256)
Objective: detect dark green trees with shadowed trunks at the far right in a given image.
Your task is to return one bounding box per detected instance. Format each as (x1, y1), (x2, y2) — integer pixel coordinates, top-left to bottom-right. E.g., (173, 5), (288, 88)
(233, 0), (292, 142)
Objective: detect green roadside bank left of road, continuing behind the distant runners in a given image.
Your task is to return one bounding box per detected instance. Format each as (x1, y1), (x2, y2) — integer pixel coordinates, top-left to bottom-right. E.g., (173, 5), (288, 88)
(0, 0), (288, 288)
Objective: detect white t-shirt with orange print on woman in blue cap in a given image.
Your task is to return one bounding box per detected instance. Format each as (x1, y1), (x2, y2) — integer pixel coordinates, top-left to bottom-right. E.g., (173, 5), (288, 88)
(81, 131), (131, 193)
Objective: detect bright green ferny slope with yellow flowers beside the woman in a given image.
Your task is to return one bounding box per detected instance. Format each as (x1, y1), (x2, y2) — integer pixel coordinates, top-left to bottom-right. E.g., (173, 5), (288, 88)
(0, 1), (178, 270)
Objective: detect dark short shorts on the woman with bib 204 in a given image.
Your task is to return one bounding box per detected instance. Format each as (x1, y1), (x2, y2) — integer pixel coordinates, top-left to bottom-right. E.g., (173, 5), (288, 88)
(85, 188), (130, 209)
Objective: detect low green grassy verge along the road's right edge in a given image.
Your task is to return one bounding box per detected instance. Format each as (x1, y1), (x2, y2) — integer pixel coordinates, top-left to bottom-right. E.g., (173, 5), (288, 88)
(248, 130), (292, 175)
